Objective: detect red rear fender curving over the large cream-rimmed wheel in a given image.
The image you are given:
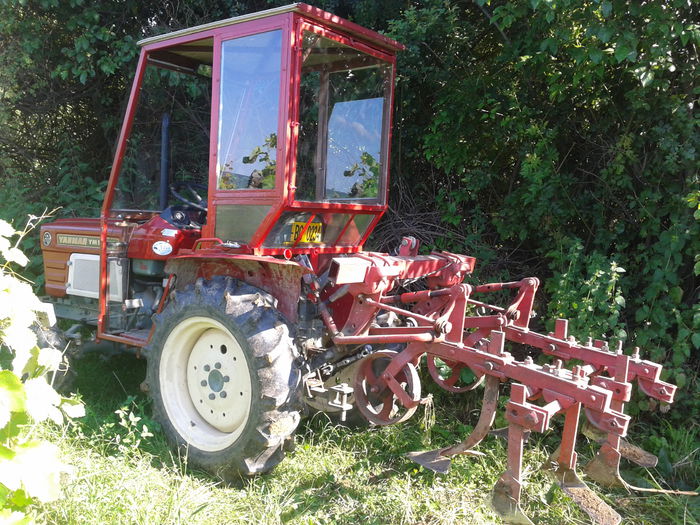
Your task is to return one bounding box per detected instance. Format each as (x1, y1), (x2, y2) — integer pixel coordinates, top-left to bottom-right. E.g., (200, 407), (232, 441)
(165, 254), (309, 323)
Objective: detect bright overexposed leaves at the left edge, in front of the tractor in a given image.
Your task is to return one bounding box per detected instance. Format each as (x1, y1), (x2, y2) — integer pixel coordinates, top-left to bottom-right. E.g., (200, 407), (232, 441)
(0, 220), (84, 523)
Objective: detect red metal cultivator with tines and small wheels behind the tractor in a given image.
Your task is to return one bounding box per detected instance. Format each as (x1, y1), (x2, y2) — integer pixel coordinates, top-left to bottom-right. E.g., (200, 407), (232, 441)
(317, 238), (696, 524)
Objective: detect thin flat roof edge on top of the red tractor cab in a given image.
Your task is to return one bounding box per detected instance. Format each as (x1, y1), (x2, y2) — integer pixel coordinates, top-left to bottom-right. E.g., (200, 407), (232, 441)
(138, 3), (406, 54)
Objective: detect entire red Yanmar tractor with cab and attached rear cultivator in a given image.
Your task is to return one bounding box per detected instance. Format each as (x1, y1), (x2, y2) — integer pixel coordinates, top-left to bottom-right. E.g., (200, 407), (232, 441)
(41, 4), (688, 523)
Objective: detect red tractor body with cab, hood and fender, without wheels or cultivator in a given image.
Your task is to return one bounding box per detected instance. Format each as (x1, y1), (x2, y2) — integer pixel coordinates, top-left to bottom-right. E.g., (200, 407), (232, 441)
(41, 4), (403, 347)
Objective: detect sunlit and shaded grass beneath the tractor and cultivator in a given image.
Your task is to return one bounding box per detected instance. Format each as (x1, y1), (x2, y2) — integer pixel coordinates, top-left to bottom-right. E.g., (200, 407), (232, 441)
(37, 354), (700, 525)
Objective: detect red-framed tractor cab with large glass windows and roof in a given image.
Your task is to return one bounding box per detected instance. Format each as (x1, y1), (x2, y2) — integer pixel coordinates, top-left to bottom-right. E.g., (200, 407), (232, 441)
(110, 4), (402, 260)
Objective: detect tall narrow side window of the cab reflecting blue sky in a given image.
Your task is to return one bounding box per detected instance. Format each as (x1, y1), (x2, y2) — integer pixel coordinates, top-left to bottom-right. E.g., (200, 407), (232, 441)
(217, 30), (282, 190)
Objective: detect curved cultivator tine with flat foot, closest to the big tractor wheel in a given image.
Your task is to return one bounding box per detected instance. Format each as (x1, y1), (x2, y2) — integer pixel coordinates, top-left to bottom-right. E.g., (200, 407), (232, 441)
(406, 376), (499, 474)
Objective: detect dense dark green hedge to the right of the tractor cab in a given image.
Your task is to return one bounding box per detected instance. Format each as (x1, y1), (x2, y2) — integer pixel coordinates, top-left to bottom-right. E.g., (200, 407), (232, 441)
(390, 0), (700, 418)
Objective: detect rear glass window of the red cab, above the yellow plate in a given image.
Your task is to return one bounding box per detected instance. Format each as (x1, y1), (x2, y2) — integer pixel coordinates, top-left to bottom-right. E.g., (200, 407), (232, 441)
(296, 31), (391, 202)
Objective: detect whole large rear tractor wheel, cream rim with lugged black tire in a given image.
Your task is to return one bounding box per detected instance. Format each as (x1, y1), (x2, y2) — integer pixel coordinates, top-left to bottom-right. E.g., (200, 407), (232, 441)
(147, 277), (300, 480)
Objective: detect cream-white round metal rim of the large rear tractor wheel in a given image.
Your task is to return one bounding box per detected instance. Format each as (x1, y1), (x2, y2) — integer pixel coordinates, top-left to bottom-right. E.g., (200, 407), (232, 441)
(159, 317), (252, 452)
